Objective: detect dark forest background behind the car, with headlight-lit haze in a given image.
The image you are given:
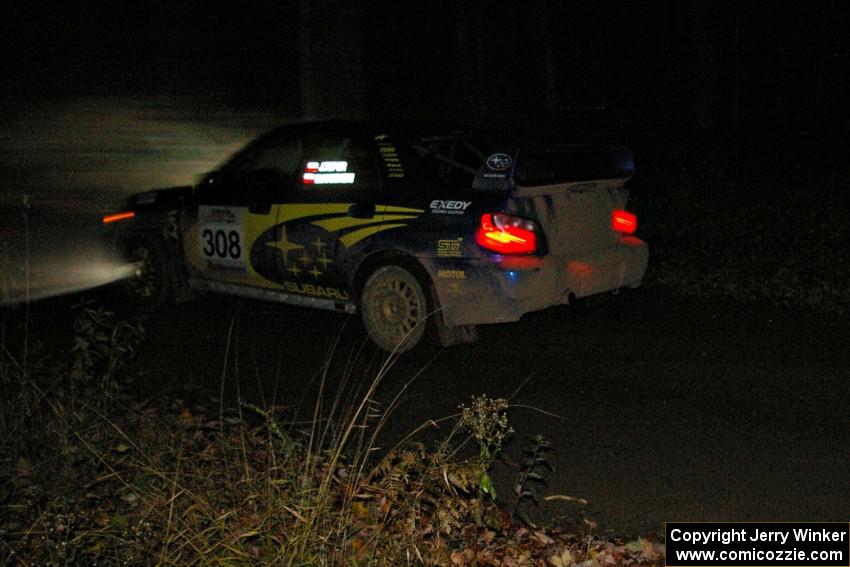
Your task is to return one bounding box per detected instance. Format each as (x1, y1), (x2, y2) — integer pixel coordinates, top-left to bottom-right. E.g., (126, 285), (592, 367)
(0, 0), (850, 311)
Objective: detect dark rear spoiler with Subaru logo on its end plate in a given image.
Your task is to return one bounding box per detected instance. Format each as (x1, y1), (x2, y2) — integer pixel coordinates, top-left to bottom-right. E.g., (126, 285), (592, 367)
(472, 146), (635, 192)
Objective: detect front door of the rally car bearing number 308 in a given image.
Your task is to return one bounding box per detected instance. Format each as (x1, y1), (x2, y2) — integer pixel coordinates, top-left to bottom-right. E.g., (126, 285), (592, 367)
(184, 135), (303, 288)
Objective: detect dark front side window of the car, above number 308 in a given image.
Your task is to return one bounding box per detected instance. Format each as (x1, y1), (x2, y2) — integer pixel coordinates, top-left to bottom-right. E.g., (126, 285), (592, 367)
(202, 137), (304, 206)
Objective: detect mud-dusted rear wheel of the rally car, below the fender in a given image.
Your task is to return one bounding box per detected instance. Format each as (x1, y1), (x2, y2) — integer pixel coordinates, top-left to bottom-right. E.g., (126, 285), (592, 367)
(360, 265), (428, 352)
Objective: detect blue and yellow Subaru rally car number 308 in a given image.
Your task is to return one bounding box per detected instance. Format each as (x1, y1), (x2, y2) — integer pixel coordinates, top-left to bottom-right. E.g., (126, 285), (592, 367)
(103, 122), (648, 351)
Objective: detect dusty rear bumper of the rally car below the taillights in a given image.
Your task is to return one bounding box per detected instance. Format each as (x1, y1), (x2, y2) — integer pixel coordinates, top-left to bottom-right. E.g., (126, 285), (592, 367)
(431, 236), (649, 326)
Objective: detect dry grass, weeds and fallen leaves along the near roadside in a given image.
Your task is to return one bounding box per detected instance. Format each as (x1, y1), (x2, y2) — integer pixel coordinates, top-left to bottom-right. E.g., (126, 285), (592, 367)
(0, 305), (663, 567)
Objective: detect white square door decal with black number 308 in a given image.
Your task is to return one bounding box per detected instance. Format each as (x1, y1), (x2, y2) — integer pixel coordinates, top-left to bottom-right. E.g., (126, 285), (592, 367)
(198, 207), (245, 273)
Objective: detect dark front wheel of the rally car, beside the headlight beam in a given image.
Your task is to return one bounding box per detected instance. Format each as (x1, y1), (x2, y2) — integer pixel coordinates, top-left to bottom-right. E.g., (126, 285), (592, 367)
(126, 237), (172, 310)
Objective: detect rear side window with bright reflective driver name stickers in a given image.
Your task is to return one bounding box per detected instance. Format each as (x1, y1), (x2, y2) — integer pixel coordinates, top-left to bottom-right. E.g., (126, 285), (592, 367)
(298, 136), (381, 194)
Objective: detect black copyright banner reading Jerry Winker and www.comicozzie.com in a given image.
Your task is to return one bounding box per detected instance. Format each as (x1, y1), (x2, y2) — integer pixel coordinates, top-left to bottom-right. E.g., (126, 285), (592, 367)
(665, 522), (850, 567)
